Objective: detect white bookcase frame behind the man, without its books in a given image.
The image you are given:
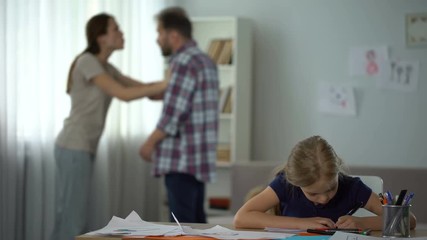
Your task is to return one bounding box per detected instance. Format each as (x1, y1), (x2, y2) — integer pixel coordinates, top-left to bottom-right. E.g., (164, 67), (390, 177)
(192, 17), (252, 167)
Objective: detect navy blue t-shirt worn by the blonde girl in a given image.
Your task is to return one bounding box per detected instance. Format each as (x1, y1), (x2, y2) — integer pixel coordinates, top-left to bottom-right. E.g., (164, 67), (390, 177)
(270, 173), (372, 222)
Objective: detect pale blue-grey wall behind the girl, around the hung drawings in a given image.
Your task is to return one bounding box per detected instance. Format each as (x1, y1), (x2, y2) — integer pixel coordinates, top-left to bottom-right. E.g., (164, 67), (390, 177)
(178, 0), (427, 169)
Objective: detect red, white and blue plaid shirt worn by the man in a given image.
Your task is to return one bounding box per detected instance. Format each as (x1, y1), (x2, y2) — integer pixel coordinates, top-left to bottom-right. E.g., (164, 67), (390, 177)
(153, 41), (219, 182)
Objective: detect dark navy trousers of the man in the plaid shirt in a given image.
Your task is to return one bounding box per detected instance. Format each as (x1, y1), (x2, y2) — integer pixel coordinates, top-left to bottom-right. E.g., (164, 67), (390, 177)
(165, 173), (206, 223)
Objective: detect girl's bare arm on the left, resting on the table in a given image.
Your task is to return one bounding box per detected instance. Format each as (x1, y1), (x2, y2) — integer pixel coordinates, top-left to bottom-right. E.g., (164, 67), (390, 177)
(234, 187), (334, 229)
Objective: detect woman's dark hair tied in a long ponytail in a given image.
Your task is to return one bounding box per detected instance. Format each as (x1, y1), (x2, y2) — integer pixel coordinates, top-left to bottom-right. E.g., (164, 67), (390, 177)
(67, 13), (113, 93)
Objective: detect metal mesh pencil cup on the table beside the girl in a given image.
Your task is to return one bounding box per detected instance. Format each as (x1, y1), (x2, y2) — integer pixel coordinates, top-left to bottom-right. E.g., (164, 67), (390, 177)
(383, 205), (411, 237)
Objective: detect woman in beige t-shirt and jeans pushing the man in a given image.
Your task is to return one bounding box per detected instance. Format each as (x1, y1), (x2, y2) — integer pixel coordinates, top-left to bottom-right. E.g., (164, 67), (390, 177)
(51, 13), (167, 240)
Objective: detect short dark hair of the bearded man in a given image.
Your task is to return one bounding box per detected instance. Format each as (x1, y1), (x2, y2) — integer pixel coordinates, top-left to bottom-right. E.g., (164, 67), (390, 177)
(156, 7), (192, 39)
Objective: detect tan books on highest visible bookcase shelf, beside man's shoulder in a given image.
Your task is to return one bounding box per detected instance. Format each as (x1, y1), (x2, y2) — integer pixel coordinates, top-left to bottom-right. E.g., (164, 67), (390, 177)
(207, 39), (233, 64)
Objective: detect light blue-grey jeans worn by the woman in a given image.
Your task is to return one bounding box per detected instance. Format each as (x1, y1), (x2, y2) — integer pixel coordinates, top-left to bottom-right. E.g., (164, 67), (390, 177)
(50, 146), (94, 240)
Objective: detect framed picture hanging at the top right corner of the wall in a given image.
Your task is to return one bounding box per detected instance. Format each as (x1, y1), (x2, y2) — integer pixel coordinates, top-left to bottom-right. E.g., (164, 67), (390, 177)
(406, 12), (427, 47)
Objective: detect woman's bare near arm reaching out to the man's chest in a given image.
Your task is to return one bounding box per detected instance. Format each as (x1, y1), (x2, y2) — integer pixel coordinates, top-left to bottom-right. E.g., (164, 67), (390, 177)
(92, 73), (168, 101)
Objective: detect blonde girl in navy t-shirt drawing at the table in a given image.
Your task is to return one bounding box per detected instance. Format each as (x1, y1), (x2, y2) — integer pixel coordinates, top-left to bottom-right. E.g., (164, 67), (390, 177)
(234, 136), (416, 230)
